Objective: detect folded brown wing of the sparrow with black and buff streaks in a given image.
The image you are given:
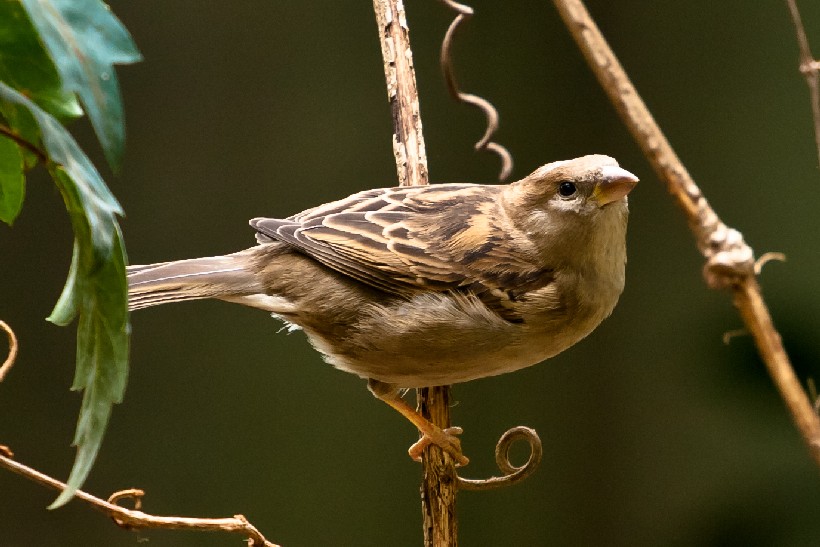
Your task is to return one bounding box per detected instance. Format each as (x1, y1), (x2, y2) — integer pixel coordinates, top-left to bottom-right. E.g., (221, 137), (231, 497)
(251, 184), (553, 322)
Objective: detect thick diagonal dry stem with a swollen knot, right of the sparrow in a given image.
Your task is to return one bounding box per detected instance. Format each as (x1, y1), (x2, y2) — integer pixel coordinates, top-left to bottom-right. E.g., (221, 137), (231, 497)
(553, 0), (820, 465)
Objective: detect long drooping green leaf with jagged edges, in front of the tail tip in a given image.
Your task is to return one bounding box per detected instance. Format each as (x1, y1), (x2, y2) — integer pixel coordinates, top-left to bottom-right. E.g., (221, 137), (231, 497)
(0, 79), (130, 508)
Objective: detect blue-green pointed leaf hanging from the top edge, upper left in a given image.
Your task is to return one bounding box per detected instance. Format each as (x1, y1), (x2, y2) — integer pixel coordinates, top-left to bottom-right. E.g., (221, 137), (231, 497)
(21, 0), (142, 170)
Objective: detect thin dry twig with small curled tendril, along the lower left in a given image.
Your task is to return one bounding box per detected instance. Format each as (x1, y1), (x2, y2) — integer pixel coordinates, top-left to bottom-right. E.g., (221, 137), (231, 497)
(0, 446), (278, 547)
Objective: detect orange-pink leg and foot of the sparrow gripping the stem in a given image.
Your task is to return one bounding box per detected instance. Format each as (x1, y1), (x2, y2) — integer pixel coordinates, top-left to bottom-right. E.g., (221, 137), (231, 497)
(367, 379), (470, 466)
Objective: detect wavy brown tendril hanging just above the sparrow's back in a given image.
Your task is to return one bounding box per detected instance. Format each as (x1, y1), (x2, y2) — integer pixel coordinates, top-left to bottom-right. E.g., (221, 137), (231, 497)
(440, 0), (512, 182)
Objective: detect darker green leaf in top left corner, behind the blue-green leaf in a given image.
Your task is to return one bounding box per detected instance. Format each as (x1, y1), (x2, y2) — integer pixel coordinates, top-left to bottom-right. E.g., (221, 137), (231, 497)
(0, 0), (83, 119)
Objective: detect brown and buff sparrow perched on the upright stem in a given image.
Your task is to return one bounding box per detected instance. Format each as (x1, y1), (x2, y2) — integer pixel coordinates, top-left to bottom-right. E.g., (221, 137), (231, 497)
(127, 155), (638, 465)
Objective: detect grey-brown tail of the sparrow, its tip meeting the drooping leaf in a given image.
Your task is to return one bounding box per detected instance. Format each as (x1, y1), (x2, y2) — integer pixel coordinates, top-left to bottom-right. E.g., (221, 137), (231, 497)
(127, 251), (264, 310)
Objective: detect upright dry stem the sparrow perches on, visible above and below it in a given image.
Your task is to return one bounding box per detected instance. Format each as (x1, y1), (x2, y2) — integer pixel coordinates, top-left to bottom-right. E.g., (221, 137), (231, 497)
(373, 0), (458, 547)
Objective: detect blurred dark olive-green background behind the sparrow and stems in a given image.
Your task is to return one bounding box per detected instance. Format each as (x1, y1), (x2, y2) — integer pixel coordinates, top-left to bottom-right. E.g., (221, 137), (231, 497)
(0, 0), (820, 547)
